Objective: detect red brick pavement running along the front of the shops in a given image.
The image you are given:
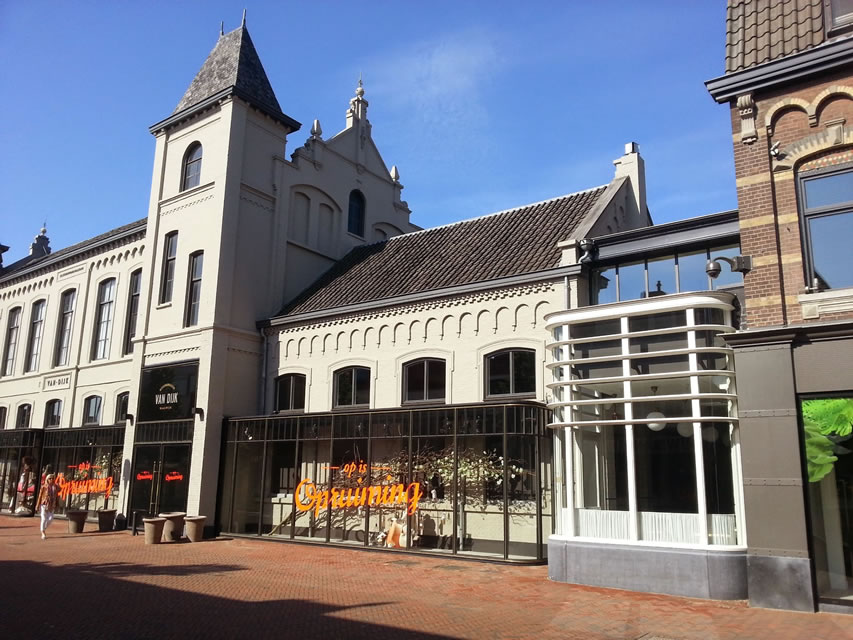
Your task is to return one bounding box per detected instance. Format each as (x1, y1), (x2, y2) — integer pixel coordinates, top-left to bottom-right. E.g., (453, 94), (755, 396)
(0, 517), (853, 640)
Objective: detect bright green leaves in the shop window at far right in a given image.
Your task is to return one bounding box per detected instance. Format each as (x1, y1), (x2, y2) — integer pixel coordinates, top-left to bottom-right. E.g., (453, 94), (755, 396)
(802, 398), (853, 482)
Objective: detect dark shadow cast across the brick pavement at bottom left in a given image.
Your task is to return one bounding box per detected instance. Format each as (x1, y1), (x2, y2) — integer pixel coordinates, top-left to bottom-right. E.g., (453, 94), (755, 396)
(0, 561), (460, 640)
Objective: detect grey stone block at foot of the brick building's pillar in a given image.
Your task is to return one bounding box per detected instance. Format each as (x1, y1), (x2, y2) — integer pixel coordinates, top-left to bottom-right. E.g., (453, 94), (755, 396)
(747, 555), (815, 611)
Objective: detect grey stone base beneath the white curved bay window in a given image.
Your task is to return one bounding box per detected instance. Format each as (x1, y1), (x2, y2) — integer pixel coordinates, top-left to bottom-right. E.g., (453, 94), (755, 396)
(548, 538), (747, 600)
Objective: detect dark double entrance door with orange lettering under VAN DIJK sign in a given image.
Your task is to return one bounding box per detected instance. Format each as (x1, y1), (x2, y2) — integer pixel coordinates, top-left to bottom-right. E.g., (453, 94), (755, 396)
(130, 444), (190, 514)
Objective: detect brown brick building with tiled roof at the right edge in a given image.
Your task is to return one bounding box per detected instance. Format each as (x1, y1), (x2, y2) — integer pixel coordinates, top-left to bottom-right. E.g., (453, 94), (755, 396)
(707, 0), (853, 610)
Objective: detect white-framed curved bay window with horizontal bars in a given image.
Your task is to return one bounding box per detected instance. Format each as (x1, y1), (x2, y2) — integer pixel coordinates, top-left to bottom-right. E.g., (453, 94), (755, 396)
(548, 292), (744, 546)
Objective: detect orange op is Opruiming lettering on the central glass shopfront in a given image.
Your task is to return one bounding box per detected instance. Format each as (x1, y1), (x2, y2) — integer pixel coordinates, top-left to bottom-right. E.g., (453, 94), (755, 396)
(295, 462), (423, 516)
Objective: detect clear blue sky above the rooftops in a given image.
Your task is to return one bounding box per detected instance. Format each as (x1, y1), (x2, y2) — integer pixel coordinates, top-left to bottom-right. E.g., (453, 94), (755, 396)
(0, 0), (737, 264)
